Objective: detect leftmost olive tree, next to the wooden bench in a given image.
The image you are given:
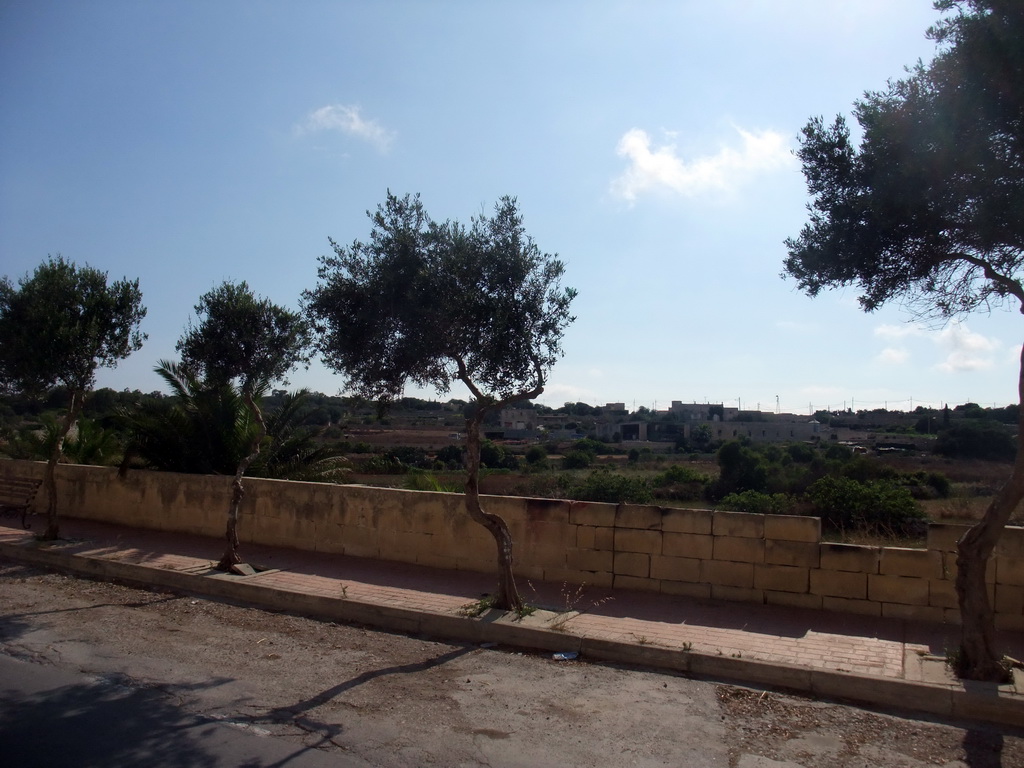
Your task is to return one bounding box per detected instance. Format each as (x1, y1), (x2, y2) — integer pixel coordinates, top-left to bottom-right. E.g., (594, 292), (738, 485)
(0, 255), (145, 540)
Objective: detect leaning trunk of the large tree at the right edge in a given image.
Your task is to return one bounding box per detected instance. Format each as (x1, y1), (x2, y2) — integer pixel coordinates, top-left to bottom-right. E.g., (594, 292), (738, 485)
(956, 347), (1024, 682)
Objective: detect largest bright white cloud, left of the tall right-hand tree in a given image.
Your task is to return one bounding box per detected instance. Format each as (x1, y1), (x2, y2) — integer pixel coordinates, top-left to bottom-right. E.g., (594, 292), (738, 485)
(611, 128), (795, 203)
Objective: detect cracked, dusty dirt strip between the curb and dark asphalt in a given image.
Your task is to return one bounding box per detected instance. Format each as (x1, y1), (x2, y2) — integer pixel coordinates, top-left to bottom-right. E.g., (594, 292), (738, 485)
(0, 560), (1024, 768)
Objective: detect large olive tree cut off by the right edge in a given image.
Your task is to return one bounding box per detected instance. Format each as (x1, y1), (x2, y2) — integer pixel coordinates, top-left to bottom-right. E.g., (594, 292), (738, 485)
(784, 0), (1024, 680)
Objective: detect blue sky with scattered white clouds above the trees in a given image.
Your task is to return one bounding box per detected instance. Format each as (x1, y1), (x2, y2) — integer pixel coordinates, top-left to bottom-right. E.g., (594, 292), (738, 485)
(0, 0), (1020, 413)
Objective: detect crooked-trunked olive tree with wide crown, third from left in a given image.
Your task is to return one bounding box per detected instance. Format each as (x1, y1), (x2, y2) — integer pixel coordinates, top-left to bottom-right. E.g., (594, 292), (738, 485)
(304, 193), (575, 610)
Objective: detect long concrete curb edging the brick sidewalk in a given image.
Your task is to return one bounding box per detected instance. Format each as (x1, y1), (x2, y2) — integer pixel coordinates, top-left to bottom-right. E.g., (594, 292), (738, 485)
(0, 542), (1024, 727)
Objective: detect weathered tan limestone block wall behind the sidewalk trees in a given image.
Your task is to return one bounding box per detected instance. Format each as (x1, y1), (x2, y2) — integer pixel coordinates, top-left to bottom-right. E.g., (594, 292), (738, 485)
(6, 461), (1024, 631)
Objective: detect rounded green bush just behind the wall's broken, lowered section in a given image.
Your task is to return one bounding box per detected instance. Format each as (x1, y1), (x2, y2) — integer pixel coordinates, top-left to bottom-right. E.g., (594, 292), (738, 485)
(807, 475), (925, 536)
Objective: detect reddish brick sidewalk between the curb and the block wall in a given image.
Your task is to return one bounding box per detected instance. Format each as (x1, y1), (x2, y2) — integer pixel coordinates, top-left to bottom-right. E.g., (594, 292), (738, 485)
(0, 518), (1024, 726)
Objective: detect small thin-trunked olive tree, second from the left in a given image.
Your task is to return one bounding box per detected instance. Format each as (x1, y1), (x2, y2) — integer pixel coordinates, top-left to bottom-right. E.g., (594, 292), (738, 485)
(177, 282), (311, 570)
